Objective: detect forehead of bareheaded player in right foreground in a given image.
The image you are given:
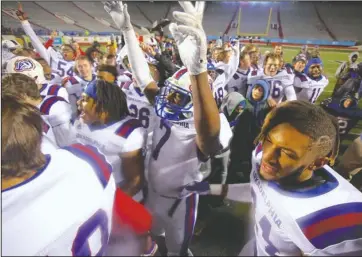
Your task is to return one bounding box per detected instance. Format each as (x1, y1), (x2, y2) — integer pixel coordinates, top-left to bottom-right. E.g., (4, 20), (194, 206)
(267, 123), (311, 155)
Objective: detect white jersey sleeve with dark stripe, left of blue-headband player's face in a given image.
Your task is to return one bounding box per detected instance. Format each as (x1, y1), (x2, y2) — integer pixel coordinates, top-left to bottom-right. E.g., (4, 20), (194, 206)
(38, 95), (73, 147)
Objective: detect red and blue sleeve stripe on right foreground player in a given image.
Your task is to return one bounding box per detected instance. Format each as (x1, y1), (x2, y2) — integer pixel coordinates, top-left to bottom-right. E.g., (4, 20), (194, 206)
(297, 202), (362, 249)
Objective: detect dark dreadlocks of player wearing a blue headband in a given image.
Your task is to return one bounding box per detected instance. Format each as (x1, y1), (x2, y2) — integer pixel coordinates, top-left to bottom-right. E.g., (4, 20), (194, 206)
(95, 80), (129, 123)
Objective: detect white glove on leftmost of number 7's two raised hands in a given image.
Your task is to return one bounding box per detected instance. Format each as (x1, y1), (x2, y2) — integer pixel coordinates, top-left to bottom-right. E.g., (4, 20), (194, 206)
(103, 1), (132, 32)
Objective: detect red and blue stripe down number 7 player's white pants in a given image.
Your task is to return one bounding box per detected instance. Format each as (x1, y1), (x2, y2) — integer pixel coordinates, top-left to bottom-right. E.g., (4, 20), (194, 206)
(180, 194), (197, 256)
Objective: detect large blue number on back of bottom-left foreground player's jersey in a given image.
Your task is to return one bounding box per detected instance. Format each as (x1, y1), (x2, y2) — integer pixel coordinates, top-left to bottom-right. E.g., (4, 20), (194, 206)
(72, 209), (110, 256)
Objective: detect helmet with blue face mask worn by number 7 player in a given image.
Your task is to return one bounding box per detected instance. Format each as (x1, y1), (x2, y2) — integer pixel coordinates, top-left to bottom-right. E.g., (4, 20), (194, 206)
(155, 67), (193, 121)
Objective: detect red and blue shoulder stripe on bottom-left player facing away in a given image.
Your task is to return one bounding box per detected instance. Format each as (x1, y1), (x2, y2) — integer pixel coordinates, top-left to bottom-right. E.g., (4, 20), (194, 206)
(63, 144), (112, 188)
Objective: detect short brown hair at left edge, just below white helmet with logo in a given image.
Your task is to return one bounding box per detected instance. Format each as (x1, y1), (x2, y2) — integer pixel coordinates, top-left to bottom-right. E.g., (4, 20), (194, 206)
(1, 73), (41, 99)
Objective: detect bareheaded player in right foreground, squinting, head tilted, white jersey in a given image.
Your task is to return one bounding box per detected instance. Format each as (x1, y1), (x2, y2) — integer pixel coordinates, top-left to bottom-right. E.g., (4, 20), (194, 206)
(183, 101), (362, 256)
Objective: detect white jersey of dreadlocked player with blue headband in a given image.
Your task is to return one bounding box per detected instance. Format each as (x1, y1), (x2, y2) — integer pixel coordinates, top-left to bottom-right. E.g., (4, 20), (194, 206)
(73, 117), (147, 183)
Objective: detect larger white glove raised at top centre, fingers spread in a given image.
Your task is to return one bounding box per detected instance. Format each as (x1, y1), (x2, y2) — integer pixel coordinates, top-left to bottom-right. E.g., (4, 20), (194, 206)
(169, 2), (207, 75)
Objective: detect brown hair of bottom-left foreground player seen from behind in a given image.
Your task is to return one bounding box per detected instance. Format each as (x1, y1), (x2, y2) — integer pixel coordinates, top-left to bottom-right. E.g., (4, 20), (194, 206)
(1, 93), (45, 178)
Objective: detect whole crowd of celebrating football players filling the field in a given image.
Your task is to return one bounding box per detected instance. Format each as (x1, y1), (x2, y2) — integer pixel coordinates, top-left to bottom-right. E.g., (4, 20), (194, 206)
(1, 1), (362, 256)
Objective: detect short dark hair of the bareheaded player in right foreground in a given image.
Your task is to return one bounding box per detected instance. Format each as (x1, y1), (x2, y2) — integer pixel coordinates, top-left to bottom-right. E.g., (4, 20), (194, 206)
(255, 100), (340, 165)
